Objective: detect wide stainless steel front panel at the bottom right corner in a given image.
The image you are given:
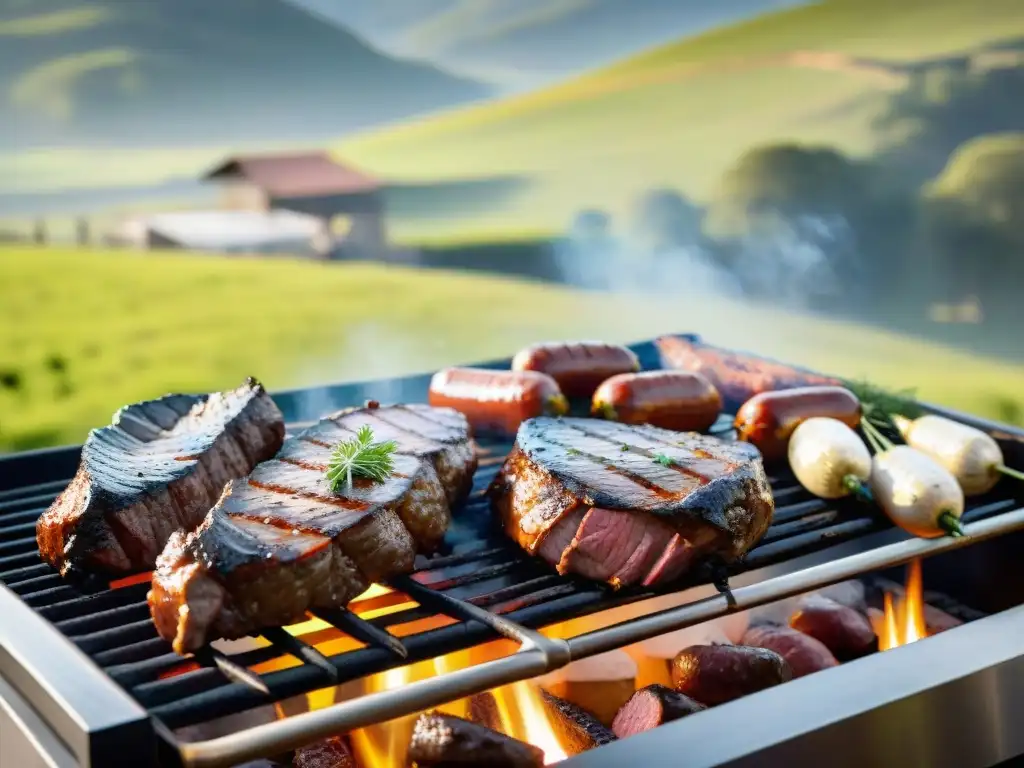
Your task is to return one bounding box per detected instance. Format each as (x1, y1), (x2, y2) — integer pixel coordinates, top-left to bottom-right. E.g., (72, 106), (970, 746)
(563, 606), (1024, 768)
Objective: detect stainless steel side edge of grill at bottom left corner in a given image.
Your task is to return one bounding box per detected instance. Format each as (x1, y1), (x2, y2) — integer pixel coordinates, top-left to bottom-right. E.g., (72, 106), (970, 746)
(0, 585), (156, 766)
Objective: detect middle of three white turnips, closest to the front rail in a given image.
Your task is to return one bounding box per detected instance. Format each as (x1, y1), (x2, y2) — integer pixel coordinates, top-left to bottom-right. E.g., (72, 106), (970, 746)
(863, 421), (964, 539)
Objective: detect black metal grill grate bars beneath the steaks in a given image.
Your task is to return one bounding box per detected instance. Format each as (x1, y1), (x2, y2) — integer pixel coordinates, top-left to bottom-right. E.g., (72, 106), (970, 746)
(0, 422), (1015, 728)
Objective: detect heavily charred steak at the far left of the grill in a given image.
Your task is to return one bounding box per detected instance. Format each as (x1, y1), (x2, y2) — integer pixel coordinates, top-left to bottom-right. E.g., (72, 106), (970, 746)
(36, 379), (285, 574)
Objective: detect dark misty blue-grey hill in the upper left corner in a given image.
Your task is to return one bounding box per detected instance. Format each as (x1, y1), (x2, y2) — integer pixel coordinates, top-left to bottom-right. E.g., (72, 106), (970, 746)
(0, 0), (489, 151)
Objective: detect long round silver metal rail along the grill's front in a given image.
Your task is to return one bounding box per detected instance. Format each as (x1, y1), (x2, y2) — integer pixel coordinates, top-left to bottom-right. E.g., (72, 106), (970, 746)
(180, 508), (1024, 768)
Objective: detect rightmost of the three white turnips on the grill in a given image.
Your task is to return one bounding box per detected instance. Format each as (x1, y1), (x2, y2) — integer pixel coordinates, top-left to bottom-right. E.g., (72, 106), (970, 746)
(893, 415), (1024, 496)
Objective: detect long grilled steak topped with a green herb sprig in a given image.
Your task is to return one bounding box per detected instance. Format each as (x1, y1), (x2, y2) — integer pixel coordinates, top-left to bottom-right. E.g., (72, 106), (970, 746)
(148, 403), (476, 653)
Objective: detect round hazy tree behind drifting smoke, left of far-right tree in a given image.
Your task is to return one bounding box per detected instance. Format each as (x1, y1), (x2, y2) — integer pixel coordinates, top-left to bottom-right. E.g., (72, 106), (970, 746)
(705, 144), (906, 307)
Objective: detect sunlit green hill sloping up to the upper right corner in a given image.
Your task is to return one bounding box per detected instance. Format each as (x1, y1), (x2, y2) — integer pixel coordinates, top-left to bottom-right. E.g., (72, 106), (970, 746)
(336, 0), (1024, 237)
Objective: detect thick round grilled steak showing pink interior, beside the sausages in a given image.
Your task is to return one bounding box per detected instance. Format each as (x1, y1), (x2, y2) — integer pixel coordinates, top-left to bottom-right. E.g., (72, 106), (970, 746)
(488, 418), (774, 587)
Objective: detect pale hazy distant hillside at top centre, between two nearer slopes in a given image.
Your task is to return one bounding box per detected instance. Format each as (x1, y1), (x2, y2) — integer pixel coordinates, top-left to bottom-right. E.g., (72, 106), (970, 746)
(291, 0), (807, 89)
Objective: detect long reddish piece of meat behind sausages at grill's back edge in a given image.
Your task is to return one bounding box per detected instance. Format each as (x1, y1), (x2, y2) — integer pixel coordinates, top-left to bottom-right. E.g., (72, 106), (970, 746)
(654, 336), (842, 408)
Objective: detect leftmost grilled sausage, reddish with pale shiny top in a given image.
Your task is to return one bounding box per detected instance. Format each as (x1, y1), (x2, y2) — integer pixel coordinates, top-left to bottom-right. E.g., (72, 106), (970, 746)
(427, 368), (568, 435)
